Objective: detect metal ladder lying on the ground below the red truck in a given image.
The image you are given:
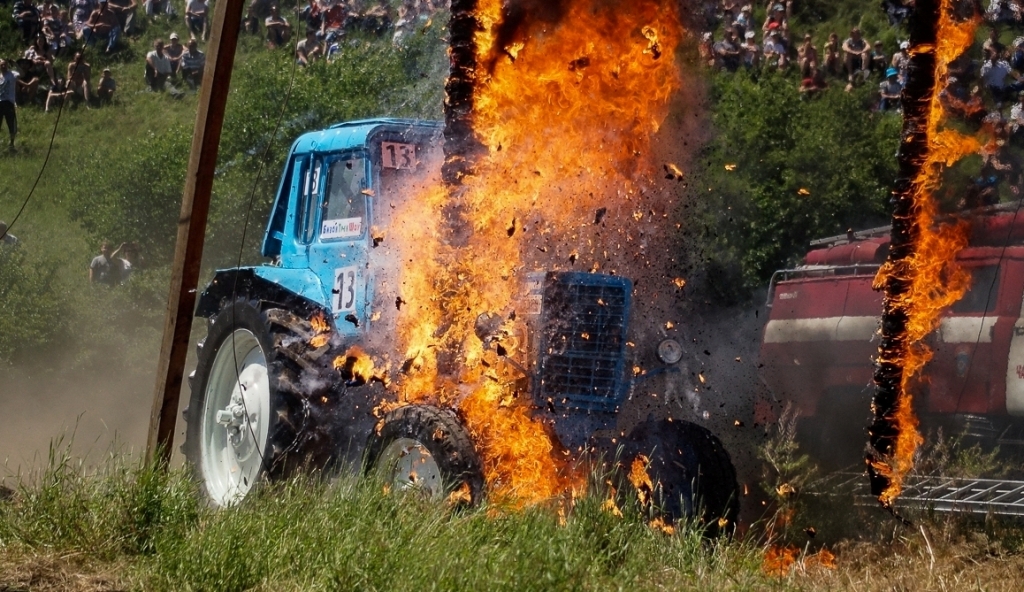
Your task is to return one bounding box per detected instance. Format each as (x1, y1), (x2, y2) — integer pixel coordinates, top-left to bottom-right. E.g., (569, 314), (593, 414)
(814, 472), (1024, 516)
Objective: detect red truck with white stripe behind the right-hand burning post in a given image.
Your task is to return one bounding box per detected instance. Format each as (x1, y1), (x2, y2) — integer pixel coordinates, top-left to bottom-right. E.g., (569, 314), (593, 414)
(756, 204), (1024, 468)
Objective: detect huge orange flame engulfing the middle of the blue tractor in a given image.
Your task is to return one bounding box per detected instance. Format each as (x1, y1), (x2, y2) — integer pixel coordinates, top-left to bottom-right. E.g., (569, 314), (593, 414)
(387, 0), (682, 505)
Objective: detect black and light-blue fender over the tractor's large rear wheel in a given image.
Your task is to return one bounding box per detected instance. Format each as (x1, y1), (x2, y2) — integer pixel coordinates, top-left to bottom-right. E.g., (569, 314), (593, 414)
(196, 266), (331, 319)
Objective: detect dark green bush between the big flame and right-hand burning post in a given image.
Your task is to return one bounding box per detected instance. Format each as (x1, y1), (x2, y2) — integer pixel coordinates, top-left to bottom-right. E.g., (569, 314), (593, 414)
(694, 72), (901, 300)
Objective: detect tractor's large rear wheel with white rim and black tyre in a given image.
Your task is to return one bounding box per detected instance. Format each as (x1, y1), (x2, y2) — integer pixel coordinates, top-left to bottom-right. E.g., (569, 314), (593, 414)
(183, 301), (302, 506)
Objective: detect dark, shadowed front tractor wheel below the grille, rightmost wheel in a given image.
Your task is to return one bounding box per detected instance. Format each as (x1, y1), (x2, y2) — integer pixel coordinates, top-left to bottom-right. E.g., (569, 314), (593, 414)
(620, 419), (739, 536)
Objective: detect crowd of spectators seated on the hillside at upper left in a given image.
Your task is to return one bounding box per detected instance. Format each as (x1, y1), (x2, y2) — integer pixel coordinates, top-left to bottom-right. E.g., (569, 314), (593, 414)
(0, 0), (447, 131)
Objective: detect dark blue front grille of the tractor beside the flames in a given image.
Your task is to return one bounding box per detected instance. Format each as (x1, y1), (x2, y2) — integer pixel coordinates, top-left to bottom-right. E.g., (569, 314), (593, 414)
(537, 272), (633, 412)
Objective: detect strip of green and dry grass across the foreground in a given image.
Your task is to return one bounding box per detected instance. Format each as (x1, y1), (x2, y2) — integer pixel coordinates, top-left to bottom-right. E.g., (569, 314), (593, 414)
(6, 446), (1024, 591)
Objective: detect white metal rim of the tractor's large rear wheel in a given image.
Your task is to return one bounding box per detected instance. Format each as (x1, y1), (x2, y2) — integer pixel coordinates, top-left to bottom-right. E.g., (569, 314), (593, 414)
(200, 329), (270, 506)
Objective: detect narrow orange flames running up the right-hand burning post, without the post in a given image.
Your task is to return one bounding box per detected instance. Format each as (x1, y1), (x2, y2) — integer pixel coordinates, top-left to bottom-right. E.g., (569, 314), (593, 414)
(873, 0), (981, 507)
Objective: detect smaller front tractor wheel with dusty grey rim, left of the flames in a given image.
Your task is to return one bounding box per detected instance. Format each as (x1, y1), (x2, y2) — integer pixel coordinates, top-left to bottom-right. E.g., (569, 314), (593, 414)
(367, 405), (483, 505)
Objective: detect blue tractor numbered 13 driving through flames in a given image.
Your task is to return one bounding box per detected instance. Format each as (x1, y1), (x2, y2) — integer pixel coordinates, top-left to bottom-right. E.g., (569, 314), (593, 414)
(183, 119), (738, 523)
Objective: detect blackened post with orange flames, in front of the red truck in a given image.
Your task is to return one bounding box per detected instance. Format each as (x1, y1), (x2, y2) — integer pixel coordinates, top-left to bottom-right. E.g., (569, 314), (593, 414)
(866, 0), (980, 509)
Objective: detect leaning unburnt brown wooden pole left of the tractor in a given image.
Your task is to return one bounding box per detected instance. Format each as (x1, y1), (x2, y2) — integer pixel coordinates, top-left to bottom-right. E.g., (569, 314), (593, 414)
(146, 0), (243, 464)
